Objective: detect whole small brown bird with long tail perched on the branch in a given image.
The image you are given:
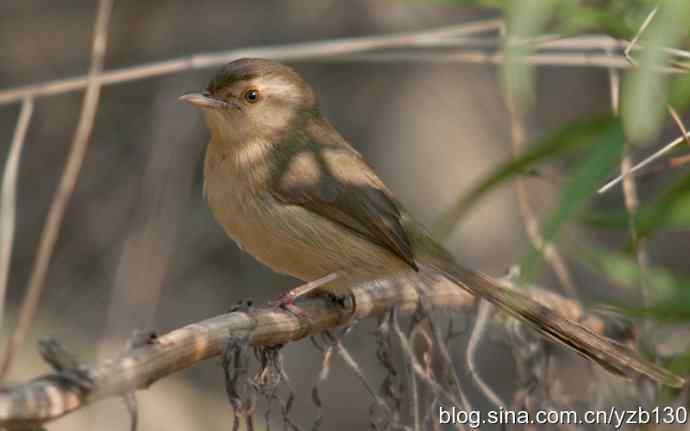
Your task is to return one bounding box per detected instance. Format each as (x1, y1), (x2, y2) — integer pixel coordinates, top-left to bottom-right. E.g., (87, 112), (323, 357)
(181, 59), (685, 386)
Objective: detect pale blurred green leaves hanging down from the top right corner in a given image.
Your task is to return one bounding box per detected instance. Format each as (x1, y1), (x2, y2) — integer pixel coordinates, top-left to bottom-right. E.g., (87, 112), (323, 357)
(448, 0), (690, 142)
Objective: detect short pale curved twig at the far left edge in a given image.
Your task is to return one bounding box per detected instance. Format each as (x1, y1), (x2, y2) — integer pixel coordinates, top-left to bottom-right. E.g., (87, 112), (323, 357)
(0, 97), (34, 330)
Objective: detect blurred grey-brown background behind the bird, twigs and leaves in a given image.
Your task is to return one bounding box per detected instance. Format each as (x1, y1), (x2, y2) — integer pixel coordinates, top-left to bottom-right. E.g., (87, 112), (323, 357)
(0, 0), (690, 430)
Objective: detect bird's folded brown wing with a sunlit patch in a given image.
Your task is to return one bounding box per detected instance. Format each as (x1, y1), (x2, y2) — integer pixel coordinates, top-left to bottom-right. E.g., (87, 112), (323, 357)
(272, 125), (418, 269)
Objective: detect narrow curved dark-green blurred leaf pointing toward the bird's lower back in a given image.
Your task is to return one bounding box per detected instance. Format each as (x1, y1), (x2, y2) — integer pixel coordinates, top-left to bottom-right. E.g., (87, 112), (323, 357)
(432, 116), (619, 238)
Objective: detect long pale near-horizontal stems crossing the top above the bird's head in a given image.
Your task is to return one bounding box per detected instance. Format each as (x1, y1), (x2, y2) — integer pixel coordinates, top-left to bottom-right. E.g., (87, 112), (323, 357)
(0, 19), (690, 105)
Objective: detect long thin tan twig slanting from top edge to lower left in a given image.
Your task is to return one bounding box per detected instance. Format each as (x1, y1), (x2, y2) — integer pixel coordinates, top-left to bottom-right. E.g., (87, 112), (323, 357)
(0, 0), (113, 376)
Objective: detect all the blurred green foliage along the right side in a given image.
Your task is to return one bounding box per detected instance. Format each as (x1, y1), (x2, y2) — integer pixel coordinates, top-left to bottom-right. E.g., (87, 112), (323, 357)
(439, 0), (690, 328)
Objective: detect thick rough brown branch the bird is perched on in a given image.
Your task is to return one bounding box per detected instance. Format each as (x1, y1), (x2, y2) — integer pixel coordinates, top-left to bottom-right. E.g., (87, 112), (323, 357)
(0, 275), (624, 427)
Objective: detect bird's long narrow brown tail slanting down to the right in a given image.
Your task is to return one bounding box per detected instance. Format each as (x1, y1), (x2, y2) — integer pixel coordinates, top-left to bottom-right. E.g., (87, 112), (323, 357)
(423, 247), (685, 387)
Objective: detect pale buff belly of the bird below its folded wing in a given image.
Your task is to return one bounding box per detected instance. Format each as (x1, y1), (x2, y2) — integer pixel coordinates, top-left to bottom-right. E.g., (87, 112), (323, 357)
(206, 177), (409, 288)
